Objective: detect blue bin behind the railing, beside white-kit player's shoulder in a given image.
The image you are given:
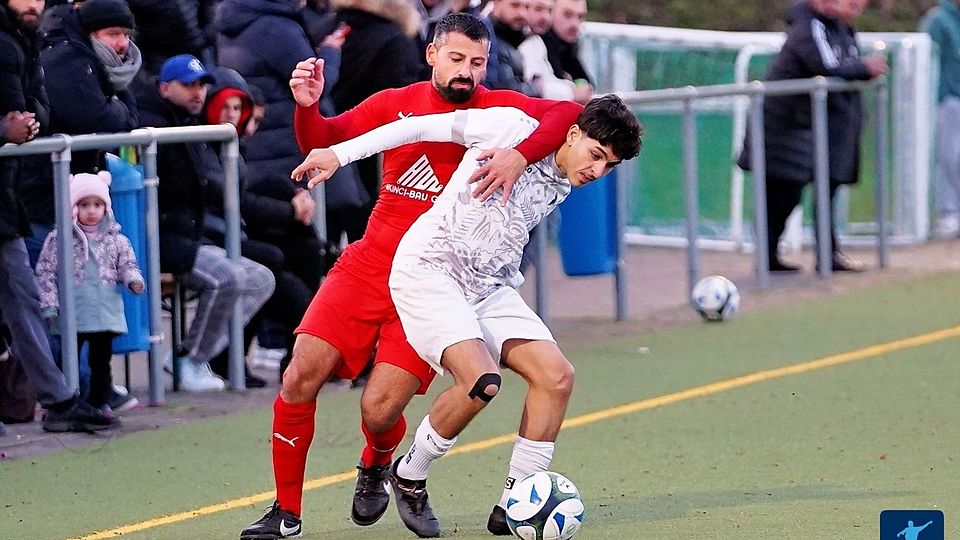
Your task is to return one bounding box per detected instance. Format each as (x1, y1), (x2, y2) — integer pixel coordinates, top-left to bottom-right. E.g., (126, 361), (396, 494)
(558, 171), (619, 276)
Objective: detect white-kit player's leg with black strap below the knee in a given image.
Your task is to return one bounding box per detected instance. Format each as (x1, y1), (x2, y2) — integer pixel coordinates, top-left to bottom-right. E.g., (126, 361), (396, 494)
(390, 339), (500, 538)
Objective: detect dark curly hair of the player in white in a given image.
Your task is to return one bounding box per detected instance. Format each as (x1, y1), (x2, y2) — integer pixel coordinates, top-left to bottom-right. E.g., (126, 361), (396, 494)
(577, 94), (643, 160)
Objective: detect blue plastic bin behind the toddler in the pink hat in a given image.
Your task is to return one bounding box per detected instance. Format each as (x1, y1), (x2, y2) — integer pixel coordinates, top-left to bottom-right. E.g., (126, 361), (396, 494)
(107, 154), (150, 354)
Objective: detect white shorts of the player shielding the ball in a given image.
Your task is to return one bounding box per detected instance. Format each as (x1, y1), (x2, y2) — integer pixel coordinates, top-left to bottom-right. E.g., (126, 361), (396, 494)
(390, 266), (556, 375)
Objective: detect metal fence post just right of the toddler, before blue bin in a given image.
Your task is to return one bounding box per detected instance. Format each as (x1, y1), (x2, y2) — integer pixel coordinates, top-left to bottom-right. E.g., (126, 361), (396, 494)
(140, 136), (164, 407)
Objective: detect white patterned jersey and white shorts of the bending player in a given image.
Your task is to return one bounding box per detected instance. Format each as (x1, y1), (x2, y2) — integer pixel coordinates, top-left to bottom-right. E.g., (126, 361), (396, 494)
(330, 107), (571, 374)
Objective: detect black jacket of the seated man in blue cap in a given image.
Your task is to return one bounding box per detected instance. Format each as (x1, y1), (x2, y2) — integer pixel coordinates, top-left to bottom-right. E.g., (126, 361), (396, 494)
(138, 84), (223, 274)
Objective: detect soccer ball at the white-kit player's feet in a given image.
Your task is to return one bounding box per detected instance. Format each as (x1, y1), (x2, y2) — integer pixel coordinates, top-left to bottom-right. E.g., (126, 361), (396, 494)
(507, 471), (583, 540)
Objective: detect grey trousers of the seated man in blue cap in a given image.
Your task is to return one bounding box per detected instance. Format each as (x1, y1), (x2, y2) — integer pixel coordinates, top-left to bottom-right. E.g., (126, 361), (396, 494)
(177, 246), (275, 362)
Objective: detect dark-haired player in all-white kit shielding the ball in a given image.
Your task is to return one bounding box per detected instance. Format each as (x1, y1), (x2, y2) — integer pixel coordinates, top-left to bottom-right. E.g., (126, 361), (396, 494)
(292, 95), (642, 537)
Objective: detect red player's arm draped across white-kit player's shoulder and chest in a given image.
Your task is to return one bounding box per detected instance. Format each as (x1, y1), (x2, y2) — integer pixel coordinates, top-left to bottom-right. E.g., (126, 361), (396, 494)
(469, 90), (583, 204)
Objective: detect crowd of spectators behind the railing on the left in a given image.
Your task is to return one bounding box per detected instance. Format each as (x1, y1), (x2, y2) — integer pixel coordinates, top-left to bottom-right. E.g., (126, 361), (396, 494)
(0, 0), (593, 431)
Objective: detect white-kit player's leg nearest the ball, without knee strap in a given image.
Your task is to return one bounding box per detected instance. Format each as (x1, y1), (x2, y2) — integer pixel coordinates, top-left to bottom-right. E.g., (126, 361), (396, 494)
(477, 289), (574, 535)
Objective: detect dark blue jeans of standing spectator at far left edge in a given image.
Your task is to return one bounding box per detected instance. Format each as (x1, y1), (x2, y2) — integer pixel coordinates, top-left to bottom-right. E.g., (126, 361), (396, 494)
(0, 238), (74, 406)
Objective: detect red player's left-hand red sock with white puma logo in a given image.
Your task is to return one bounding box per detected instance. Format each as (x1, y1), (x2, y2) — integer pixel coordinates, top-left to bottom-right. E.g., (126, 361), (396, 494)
(271, 395), (316, 516)
